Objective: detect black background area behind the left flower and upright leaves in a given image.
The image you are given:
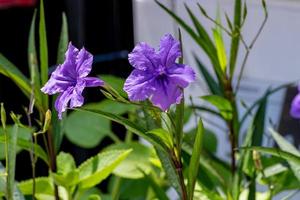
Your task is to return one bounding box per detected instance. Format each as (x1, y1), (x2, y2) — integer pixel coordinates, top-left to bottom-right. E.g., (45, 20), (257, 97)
(0, 0), (133, 180)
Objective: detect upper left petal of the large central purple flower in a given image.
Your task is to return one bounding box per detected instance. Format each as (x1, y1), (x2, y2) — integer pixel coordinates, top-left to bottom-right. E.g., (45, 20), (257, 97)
(128, 42), (159, 71)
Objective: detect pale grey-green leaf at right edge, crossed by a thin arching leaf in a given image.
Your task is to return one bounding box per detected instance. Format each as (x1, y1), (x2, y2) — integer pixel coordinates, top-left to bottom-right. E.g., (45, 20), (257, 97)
(269, 129), (300, 183)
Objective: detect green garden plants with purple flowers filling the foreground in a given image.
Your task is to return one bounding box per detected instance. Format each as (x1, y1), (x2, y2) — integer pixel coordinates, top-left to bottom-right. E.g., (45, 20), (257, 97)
(0, 0), (300, 200)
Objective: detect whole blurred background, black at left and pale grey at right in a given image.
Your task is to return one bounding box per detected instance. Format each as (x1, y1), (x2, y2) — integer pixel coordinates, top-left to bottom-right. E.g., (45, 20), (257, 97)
(0, 0), (300, 199)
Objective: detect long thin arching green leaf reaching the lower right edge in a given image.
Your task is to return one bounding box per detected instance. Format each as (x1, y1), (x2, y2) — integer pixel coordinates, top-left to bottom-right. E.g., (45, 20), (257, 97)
(241, 146), (300, 165)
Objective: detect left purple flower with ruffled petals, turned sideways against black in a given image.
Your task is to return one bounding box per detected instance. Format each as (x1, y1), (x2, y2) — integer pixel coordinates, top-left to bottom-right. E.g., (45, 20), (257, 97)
(41, 42), (104, 119)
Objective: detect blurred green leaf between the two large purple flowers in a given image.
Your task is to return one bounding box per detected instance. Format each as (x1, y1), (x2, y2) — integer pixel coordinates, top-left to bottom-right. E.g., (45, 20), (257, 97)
(99, 74), (127, 97)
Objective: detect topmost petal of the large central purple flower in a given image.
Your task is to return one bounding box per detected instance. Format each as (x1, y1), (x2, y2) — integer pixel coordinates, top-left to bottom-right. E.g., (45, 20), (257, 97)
(159, 34), (181, 67)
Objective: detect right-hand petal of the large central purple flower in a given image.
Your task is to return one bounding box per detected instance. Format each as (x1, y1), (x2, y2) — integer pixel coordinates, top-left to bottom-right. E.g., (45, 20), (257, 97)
(167, 64), (196, 88)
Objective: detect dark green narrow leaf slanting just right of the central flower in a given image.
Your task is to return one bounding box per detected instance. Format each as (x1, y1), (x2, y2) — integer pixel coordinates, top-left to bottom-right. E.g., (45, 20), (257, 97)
(194, 55), (223, 96)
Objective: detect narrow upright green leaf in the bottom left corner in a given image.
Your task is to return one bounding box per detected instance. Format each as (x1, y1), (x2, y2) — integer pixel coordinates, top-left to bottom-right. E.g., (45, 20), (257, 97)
(7, 124), (19, 199)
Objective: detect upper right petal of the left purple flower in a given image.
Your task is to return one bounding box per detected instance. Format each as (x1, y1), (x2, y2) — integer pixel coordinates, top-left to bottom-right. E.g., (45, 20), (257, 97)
(76, 48), (93, 78)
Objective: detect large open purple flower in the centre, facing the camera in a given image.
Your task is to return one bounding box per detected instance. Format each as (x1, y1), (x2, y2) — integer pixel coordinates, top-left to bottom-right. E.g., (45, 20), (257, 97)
(124, 34), (195, 111)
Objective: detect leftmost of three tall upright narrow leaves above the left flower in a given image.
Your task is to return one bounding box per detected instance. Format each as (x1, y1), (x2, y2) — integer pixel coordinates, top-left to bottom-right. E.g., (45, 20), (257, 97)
(28, 10), (43, 112)
